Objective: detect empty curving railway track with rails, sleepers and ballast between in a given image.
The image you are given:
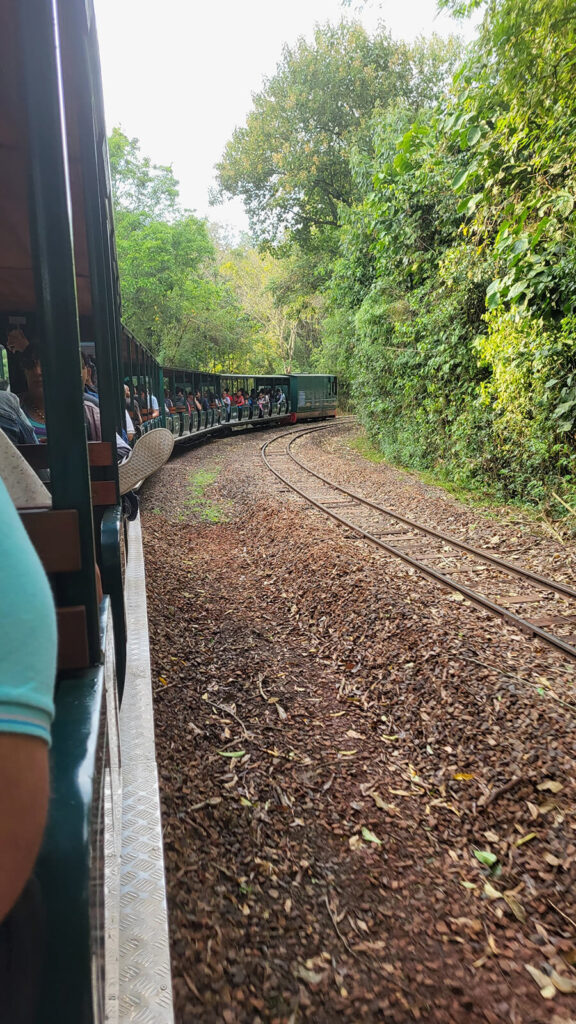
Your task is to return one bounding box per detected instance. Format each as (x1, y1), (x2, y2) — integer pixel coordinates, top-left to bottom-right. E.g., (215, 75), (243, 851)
(260, 420), (576, 659)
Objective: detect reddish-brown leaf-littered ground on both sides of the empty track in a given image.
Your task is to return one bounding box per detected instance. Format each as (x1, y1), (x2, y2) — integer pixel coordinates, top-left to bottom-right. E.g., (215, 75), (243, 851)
(142, 417), (576, 1024)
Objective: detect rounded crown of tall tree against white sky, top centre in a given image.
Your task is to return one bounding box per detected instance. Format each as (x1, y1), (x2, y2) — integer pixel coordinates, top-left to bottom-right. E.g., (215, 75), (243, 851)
(213, 22), (457, 246)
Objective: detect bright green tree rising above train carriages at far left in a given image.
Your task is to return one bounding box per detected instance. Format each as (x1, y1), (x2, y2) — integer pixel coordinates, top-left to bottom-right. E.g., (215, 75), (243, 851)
(110, 128), (246, 370)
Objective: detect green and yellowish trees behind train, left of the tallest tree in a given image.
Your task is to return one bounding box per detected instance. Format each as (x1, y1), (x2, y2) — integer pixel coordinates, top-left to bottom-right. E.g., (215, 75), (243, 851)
(109, 128), (318, 373)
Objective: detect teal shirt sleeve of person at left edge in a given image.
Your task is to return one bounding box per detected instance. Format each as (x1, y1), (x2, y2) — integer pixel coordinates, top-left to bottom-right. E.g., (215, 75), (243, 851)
(0, 479), (57, 742)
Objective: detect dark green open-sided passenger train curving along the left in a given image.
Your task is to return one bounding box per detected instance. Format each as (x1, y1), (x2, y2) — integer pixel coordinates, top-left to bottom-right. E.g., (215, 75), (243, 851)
(0, 0), (336, 1024)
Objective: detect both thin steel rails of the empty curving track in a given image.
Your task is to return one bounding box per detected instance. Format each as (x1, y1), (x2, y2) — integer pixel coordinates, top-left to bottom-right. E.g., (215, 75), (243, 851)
(260, 423), (576, 659)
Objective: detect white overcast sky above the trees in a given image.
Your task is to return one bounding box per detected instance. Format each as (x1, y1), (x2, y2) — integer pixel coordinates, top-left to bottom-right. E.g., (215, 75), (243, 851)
(90, 0), (472, 228)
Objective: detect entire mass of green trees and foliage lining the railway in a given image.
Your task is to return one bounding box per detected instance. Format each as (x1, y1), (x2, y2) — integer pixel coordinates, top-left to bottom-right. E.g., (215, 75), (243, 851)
(111, 0), (576, 503)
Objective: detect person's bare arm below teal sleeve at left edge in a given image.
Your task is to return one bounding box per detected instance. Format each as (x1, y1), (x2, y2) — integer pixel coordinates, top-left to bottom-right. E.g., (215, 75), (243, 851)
(0, 733), (49, 922)
